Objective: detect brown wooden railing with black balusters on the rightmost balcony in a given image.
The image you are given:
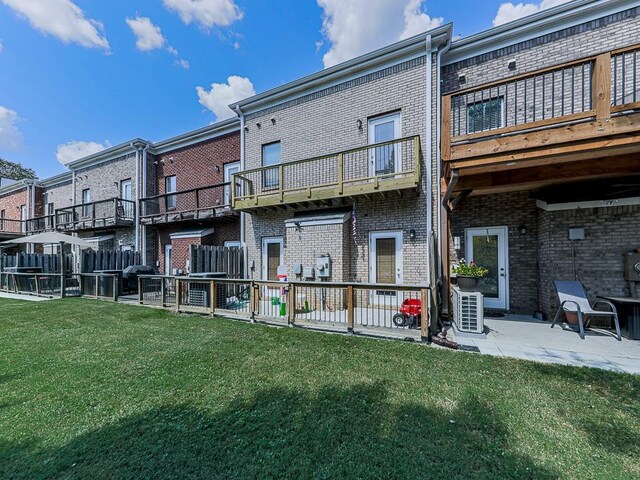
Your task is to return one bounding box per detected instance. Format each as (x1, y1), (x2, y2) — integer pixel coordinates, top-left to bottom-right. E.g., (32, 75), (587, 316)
(441, 45), (640, 168)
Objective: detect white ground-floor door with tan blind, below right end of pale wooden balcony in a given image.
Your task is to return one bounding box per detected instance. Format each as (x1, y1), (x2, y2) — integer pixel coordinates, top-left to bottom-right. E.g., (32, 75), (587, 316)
(369, 231), (403, 304)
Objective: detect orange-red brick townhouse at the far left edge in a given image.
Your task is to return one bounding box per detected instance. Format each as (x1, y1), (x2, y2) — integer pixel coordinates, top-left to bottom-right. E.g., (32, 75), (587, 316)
(0, 180), (42, 251)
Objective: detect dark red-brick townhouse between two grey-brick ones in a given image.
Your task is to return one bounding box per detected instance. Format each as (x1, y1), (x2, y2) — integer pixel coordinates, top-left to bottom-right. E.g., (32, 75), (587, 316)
(140, 119), (240, 275)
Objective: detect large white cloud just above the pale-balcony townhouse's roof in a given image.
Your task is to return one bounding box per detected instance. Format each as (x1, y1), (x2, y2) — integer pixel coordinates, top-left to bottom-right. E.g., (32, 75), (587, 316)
(316, 0), (443, 68)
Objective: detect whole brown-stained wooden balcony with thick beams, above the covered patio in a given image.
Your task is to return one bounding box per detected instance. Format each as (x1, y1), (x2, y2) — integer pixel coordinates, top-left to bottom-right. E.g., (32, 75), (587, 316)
(441, 45), (640, 195)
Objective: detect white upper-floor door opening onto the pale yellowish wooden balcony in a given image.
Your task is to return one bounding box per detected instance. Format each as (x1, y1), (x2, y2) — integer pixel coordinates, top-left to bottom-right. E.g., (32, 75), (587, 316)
(369, 113), (402, 177)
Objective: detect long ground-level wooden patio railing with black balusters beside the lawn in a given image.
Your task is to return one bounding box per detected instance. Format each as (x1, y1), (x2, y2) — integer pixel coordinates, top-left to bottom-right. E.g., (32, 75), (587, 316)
(138, 275), (435, 340)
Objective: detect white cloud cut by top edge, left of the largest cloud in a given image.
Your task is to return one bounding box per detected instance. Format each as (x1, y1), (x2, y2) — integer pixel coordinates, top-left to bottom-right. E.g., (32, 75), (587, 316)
(163, 0), (243, 28)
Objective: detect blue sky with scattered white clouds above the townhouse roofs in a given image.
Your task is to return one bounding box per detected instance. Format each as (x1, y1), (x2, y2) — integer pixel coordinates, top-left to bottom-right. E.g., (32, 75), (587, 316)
(0, 0), (566, 178)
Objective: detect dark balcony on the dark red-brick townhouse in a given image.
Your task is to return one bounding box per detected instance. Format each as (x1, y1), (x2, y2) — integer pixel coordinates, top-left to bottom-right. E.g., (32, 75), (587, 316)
(140, 182), (238, 225)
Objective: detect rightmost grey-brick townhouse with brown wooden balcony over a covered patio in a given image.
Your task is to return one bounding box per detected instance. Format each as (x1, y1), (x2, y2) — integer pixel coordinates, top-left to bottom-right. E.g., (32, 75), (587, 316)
(441, 0), (640, 316)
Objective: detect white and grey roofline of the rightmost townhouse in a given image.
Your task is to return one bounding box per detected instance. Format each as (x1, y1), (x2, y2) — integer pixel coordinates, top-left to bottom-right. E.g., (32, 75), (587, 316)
(442, 0), (640, 65)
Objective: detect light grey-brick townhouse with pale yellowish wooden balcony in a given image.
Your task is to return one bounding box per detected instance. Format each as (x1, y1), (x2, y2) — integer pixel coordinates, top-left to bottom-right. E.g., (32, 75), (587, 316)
(230, 25), (451, 288)
